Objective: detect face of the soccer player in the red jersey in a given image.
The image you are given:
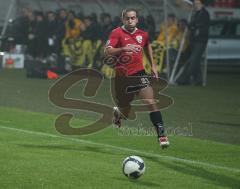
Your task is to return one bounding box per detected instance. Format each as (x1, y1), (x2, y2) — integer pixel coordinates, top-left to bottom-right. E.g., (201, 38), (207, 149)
(122, 11), (138, 32)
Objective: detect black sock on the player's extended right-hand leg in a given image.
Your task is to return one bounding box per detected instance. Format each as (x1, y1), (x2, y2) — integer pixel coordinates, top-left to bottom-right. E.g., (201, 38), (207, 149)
(150, 111), (165, 137)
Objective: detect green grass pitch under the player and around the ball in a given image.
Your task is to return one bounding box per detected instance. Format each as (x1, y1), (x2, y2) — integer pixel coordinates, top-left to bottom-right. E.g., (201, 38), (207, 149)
(0, 70), (240, 189)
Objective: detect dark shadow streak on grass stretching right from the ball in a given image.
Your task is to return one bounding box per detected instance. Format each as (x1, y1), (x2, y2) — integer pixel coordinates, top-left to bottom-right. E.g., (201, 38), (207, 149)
(142, 156), (240, 189)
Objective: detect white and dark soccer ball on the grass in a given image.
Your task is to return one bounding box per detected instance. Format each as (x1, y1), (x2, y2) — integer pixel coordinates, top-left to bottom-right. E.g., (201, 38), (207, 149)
(122, 156), (145, 179)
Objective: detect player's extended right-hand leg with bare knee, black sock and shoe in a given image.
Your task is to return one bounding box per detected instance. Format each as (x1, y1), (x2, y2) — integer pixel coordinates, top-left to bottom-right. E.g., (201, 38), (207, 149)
(139, 86), (169, 148)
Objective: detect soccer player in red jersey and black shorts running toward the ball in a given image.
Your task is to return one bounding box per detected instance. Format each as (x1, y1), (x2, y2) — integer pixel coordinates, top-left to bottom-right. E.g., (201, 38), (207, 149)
(104, 8), (169, 148)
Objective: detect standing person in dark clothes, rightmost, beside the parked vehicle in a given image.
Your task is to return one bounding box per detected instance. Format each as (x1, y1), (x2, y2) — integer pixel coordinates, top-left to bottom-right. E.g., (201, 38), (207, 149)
(179, 0), (210, 85)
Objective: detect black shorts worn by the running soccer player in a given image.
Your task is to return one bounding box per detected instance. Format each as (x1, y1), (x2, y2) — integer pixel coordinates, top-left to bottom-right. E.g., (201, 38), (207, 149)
(114, 71), (151, 108)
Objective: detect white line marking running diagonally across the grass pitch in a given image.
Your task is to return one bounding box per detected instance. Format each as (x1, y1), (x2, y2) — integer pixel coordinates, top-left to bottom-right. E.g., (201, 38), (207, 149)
(0, 125), (240, 173)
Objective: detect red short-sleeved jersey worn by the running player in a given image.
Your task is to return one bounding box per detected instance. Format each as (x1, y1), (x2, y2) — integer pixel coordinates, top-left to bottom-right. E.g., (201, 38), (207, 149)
(106, 27), (149, 75)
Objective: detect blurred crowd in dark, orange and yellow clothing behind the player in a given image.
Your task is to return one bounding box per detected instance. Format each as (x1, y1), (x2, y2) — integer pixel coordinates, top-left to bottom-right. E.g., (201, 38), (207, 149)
(4, 8), (197, 77)
